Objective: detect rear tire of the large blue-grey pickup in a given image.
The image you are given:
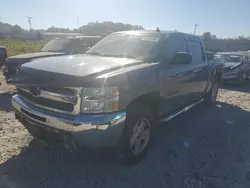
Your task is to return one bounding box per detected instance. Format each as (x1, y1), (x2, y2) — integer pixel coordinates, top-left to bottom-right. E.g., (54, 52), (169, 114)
(204, 78), (220, 105)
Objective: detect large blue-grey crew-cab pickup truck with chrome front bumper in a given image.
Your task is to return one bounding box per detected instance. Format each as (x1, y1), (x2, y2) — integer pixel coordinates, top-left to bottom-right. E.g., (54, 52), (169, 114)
(12, 31), (223, 162)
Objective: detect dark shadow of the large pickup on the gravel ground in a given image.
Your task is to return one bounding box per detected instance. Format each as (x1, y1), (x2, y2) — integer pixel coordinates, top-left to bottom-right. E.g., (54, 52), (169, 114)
(0, 100), (250, 188)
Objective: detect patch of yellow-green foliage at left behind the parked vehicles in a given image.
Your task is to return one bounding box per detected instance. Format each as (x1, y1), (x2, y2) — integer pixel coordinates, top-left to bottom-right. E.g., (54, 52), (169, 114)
(0, 39), (46, 57)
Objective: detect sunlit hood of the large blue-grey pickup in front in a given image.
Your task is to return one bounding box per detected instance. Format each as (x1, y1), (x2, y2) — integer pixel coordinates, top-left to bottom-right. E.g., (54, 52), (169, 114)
(15, 55), (148, 87)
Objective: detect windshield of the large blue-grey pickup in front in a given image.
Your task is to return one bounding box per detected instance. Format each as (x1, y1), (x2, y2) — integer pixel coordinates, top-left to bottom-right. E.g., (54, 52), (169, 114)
(87, 33), (163, 60)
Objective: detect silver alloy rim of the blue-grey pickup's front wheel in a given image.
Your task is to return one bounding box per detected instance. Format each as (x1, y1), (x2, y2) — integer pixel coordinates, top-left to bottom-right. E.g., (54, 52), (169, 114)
(130, 118), (151, 154)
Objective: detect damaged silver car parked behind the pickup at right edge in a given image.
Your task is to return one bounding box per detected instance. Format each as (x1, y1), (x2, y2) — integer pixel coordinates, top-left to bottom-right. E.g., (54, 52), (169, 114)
(216, 52), (250, 84)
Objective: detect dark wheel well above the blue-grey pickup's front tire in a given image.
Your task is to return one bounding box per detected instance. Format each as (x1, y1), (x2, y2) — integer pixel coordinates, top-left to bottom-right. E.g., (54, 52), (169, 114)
(127, 92), (160, 116)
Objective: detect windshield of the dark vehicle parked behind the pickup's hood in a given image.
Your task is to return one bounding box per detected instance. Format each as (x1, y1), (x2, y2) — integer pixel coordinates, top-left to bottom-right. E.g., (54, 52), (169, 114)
(41, 39), (72, 53)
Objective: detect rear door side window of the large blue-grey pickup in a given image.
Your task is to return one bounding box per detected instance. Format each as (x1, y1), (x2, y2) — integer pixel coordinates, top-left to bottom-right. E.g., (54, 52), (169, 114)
(188, 40), (205, 62)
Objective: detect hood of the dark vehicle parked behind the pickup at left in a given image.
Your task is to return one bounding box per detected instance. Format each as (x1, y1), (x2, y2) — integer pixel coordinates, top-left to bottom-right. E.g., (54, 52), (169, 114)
(6, 52), (64, 65)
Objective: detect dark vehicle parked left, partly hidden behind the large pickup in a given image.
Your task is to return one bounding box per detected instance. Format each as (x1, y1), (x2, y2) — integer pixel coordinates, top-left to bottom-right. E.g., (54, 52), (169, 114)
(4, 36), (102, 80)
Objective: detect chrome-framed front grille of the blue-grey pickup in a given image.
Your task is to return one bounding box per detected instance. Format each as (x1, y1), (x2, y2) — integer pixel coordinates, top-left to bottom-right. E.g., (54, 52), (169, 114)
(17, 86), (81, 115)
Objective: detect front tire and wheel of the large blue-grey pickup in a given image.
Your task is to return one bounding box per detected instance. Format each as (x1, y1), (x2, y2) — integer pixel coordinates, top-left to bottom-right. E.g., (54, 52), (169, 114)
(122, 105), (154, 163)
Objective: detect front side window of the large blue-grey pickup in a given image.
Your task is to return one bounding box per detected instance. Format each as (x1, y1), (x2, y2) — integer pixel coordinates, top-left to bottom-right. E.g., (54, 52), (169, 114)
(165, 36), (188, 59)
